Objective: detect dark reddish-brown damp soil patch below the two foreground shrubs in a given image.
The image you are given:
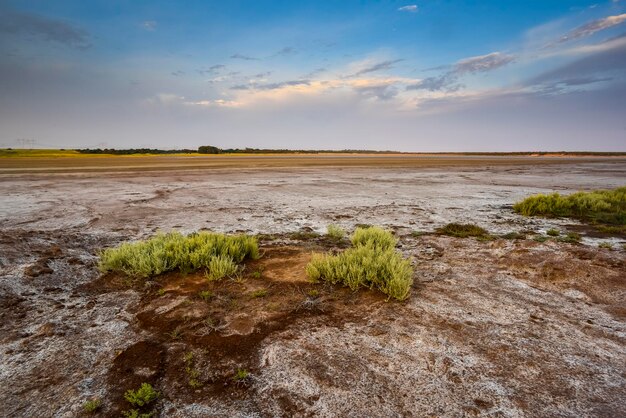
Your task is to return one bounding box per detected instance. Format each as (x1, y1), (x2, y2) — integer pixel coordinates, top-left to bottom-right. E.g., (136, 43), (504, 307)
(97, 245), (385, 414)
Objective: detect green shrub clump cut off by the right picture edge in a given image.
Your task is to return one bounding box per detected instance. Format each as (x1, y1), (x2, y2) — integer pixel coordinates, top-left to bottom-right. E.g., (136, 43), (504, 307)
(513, 187), (626, 225)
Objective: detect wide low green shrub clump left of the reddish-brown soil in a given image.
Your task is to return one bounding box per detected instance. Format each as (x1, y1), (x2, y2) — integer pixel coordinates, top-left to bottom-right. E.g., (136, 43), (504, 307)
(98, 231), (259, 280)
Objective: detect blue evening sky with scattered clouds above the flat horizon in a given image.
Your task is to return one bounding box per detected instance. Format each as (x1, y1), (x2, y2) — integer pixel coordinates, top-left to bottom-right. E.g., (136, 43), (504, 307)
(0, 0), (626, 152)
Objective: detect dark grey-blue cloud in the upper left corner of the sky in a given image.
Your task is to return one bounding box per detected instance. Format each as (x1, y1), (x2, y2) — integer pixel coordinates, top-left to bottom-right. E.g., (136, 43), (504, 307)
(0, 12), (91, 49)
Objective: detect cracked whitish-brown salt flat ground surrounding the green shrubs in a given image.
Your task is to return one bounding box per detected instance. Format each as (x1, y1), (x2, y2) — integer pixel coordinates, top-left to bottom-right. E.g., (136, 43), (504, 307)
(0, 156), (626, 417)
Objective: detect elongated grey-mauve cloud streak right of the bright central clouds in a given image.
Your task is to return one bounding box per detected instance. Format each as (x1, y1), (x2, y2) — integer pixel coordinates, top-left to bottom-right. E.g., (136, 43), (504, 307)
(406, 52), (515, 92)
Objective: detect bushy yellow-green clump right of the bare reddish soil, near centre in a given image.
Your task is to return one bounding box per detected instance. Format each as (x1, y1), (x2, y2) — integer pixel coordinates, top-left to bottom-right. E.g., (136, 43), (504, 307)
(306, 227), (413, 300)
